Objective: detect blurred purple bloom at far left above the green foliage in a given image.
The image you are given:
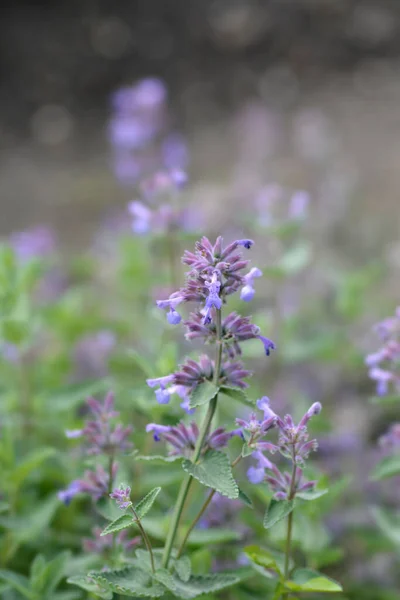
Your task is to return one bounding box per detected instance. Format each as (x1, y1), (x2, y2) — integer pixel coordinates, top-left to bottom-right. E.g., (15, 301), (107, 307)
(10, 227), (56, 262)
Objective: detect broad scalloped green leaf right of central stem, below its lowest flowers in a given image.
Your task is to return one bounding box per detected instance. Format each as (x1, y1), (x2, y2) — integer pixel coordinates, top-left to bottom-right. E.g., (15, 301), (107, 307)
(182, 450), (239, 499)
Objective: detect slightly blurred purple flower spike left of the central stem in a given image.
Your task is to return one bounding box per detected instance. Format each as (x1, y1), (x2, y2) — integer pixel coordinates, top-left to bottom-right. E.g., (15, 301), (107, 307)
(58, 392), (132, 505)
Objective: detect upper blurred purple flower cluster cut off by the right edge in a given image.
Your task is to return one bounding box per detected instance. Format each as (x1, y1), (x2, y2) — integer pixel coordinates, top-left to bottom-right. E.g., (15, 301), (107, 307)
(365, 306), (400, 396)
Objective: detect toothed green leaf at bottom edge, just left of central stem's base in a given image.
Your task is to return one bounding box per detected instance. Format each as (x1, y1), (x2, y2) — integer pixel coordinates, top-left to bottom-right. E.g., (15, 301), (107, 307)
(89, 568), (165, 598)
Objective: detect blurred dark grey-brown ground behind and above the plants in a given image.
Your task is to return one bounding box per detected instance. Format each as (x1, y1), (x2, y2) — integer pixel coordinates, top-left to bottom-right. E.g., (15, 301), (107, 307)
(0, 0), (400, 256)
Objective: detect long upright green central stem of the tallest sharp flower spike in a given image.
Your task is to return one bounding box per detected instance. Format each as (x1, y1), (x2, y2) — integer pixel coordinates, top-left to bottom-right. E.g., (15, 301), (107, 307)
(162, 310), (222, 569)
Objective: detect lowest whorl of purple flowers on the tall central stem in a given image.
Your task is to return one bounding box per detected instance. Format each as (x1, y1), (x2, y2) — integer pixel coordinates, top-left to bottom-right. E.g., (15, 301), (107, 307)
(146, 421), (241, 458)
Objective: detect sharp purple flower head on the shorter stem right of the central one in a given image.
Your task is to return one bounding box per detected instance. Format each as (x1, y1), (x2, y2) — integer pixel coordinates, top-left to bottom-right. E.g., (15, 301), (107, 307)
(247, 398), (321, 500)
